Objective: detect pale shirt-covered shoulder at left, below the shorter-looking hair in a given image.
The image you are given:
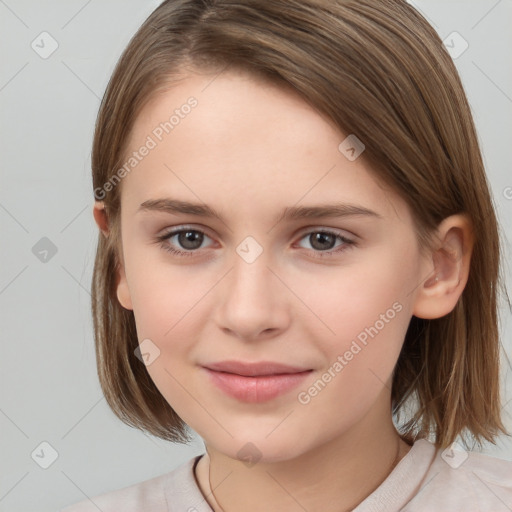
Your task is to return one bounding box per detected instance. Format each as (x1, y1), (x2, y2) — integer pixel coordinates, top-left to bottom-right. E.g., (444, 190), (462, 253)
(59, 456), (200, 512)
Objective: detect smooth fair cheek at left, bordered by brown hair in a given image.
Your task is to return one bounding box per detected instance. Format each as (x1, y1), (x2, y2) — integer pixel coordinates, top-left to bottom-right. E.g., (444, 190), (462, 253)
(126, 248), (210, 402)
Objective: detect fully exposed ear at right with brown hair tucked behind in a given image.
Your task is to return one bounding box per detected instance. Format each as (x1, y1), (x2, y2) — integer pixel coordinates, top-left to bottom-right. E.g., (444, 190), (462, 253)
(412, 214), (474, 319)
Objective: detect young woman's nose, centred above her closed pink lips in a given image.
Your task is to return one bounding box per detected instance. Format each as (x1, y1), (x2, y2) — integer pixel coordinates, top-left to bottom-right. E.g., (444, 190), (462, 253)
(215, 243), (290, 341)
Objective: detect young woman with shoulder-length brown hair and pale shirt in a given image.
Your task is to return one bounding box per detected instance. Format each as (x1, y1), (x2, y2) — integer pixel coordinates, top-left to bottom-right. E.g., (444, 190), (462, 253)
(65, 0), (512, 512)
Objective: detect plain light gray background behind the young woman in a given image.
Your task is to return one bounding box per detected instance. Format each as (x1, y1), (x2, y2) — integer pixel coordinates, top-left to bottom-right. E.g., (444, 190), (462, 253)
(0, 0), (512, 512)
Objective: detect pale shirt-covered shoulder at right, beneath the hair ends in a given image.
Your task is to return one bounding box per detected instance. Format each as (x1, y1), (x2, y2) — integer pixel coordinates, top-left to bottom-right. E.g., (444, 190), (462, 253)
(403, 444), (512, 512)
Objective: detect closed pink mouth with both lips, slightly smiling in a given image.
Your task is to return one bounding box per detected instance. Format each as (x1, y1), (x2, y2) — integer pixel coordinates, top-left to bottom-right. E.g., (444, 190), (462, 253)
(203, 361), (313, 403)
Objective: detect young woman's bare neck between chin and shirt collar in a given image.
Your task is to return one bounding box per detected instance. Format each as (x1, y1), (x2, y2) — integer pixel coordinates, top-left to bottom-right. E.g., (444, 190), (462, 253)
(196, 400), (410, 512)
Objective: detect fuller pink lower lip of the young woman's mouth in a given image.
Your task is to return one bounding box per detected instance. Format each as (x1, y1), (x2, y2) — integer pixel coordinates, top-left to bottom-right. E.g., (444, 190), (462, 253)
(205, 368), (312, 403)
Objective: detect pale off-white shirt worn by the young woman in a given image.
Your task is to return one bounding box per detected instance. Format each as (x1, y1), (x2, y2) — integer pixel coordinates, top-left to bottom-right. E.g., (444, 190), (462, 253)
(60, 439), (512, 512)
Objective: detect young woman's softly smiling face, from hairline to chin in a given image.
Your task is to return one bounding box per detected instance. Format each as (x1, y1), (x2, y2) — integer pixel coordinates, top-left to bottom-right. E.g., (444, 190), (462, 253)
(109, 72), (428, 461)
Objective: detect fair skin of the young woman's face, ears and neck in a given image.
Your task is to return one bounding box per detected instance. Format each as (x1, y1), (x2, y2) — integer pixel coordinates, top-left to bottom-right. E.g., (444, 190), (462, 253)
(94, 71), (472, 512)
